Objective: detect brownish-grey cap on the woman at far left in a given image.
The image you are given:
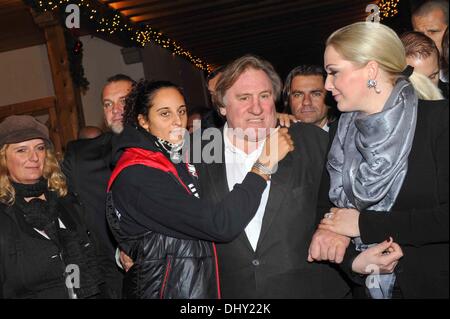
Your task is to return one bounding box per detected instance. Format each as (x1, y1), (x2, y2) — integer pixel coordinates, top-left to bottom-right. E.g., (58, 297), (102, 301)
(0, 115), (52, 147)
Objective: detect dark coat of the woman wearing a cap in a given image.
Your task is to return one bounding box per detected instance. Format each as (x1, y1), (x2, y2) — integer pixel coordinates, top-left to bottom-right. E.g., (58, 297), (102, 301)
(0, 196), (101, 299)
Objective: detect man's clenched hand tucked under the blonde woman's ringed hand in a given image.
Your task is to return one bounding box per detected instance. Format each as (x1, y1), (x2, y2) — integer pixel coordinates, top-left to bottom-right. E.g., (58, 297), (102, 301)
(308, 229), (350, 264)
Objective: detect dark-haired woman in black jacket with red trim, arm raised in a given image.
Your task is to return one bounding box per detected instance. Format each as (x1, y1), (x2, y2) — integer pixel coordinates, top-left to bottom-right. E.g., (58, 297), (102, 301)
(107, 81), (293, 298)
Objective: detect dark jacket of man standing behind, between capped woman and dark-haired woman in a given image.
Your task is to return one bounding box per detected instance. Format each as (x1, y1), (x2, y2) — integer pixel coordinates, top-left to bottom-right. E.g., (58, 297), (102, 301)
(62, 133), (122, 298)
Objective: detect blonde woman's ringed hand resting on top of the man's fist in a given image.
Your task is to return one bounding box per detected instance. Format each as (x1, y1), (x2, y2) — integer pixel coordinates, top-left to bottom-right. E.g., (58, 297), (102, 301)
(319, 207), (360, 237)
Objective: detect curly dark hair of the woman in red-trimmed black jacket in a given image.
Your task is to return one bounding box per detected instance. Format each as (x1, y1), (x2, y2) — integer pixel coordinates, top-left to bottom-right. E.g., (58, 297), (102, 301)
(123, 80), (184, 127)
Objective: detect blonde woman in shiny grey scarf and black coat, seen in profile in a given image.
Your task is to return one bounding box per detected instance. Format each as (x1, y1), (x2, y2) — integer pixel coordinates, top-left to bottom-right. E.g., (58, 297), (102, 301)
(310, 23), (449, 298)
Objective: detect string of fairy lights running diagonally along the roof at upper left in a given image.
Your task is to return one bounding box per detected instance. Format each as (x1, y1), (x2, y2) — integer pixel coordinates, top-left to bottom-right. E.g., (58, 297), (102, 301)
(30, 0), (212, 72)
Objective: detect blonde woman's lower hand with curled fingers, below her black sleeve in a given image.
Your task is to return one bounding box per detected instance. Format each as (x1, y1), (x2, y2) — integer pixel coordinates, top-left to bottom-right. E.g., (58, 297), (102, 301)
(352, 237), (403, 275)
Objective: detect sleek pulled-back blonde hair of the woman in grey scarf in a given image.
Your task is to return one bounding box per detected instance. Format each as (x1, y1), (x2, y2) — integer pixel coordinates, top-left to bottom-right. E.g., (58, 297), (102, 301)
(326, 22), (443, 100)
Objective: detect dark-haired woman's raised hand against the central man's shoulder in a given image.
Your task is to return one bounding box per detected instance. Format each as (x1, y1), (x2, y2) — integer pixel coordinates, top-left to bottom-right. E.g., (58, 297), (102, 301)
(258, 127), (294, 170)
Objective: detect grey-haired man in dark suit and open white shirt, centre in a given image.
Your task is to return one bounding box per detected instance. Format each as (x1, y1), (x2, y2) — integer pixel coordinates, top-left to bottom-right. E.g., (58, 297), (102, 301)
(197, 56), (349, 298)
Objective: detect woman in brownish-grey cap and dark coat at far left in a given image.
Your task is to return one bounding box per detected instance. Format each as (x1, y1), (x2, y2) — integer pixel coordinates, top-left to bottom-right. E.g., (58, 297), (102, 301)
(0, 115), (100, 299)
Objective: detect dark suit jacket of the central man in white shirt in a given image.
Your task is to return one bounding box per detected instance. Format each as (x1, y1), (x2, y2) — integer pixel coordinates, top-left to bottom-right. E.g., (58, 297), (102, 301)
(197, 123), (349, 298)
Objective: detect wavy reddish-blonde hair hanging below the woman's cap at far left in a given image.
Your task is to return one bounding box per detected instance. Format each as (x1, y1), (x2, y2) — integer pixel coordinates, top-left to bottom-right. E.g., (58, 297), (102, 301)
(0, 144), (67, 206)
